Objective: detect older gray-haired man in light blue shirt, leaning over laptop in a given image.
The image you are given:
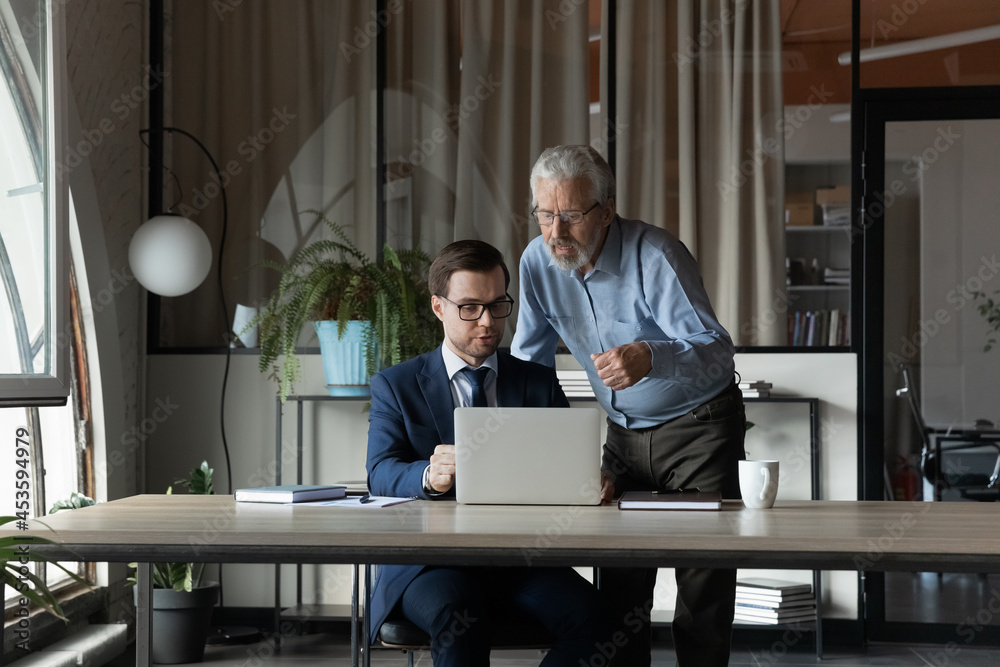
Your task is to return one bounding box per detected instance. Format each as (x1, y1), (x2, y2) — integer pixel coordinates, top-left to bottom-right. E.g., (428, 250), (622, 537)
(511, 146), (746, 667)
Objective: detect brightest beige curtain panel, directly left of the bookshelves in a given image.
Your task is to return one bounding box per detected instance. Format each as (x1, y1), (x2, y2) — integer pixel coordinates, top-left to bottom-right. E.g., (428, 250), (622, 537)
(675, 0), (786, 345)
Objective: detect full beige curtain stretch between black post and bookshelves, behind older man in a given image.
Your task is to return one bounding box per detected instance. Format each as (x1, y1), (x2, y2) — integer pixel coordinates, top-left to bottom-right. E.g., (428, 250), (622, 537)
(604, 0), (785, 345)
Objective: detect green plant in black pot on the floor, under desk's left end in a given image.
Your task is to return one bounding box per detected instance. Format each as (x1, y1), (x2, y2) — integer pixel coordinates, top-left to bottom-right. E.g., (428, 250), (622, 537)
(129, 461), (219, 664)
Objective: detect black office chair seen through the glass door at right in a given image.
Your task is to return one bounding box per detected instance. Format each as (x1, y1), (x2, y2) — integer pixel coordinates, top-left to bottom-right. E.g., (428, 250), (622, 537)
(896, 364), (1000, 501)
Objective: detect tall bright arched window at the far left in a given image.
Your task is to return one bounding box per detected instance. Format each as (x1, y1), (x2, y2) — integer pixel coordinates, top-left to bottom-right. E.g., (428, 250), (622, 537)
(0, 0), (85, 612)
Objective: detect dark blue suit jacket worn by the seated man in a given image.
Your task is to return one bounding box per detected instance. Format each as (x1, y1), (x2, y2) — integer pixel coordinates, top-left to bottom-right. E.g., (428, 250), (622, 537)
(366, 348), (569, 641)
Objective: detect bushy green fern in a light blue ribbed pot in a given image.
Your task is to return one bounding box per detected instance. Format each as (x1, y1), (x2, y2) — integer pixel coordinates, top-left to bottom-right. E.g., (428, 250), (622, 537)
(247, 211), (440, 401)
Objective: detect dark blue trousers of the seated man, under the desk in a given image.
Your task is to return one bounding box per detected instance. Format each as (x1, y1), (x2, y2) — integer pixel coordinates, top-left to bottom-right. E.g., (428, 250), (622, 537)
(400, 567), (611, 667)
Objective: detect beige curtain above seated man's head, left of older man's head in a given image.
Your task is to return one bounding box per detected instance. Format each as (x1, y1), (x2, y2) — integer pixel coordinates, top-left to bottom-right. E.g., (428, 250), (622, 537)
(454, 0), (589, 316)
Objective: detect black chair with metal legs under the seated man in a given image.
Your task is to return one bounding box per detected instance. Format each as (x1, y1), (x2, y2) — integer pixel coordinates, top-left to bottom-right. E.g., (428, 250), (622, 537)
(361, 565), (555, 667)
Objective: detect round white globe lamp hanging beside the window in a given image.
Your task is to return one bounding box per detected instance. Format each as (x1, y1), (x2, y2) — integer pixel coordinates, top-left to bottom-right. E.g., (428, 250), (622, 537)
(128, 215), (212, 296)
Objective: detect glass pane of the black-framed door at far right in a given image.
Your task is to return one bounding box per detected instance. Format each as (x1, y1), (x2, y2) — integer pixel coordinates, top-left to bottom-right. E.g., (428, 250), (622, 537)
(883, 119), (1000, 628)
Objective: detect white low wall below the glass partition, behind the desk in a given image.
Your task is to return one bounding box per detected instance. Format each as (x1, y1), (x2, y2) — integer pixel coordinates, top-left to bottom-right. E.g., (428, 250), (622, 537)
(140, 354), (857, 618)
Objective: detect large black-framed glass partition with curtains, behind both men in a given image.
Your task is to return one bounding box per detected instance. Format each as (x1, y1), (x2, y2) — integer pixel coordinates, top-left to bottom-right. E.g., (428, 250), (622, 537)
(158, 0), (850, 350)
